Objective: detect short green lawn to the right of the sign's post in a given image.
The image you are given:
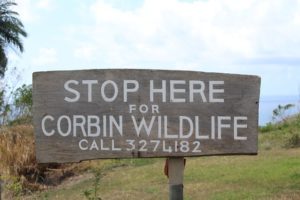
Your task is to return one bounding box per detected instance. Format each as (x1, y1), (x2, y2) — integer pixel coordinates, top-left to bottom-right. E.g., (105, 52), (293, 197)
(185, 150), (300, 199)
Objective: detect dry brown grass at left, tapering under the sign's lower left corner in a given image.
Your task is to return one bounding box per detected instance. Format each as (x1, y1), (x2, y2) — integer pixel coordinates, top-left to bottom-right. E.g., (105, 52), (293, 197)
(0, 124), (94, 197)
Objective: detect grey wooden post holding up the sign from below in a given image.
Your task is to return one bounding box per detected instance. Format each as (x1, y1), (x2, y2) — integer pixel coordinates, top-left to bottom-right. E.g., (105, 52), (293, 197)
(168, 157), (184, 200)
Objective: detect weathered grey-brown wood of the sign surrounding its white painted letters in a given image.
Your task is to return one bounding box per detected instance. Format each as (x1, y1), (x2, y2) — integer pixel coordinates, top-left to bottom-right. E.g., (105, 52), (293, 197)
(33, 69), (260, 163)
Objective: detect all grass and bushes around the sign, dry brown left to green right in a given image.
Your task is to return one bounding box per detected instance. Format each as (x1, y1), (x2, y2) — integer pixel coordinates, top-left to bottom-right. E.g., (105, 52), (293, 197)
(0, 85), (300, 200)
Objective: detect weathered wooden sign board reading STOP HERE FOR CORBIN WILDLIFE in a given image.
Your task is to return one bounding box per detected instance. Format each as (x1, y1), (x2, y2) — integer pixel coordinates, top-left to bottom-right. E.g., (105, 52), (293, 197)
(33, 69), (260, 163)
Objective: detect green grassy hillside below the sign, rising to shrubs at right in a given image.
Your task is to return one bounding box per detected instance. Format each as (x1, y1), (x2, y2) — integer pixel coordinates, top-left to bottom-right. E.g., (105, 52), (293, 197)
(0, 116), (300, 200)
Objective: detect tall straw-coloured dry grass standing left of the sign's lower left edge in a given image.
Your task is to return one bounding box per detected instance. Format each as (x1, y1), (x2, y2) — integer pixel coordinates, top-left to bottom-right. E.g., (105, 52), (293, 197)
(0, 125), (45, 194)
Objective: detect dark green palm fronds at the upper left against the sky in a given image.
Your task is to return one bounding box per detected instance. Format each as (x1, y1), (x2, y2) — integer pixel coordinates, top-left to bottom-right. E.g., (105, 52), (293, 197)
(0, 0), (27, 77)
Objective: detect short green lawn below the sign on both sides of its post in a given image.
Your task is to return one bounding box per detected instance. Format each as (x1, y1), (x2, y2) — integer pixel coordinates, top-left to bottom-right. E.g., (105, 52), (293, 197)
(25, 148), (300, 200)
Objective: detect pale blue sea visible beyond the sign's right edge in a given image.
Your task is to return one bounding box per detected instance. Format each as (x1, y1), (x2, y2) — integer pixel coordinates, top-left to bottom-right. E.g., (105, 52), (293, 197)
(259, 96), (300, 126)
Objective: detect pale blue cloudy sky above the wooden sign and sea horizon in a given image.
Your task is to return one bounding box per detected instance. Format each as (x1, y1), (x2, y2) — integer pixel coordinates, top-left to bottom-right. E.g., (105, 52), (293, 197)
(5, 0), (300, 96)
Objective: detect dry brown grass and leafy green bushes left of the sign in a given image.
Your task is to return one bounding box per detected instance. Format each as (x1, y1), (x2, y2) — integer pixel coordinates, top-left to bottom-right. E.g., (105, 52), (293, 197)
(0, 85), (81, 198)
